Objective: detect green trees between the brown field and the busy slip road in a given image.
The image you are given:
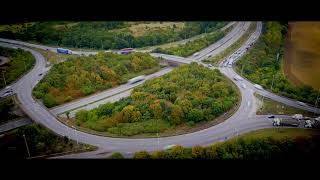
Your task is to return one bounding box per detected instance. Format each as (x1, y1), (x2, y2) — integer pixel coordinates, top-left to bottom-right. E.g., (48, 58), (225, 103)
(236, 22), (320, 104)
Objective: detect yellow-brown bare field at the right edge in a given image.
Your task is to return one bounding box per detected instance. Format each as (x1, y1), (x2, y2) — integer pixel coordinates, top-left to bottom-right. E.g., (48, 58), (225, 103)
(284, 22), (320, 89)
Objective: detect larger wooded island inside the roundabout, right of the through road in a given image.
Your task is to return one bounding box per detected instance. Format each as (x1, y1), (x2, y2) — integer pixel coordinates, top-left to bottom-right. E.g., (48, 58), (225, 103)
(76, 63), (239, 136)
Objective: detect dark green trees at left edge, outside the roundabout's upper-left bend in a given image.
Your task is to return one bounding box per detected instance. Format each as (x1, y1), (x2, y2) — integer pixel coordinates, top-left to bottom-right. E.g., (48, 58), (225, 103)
(0, 47), (35, 88)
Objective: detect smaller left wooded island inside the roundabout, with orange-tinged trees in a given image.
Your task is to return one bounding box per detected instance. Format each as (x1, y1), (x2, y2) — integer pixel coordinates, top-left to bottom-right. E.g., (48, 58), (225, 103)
(33, 52), (160, 107)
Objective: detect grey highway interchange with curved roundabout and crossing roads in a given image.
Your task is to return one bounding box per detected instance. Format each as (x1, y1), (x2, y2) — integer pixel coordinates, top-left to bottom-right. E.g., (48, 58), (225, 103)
(0, 22), (320, 158)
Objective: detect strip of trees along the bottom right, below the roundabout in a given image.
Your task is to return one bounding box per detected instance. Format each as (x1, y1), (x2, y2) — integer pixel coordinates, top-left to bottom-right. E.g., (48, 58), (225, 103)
(129, 136), (320, 160)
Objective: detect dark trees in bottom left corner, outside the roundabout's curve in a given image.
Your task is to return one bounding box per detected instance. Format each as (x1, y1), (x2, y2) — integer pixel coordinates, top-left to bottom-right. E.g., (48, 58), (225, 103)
(0, 124), (95, 159)
